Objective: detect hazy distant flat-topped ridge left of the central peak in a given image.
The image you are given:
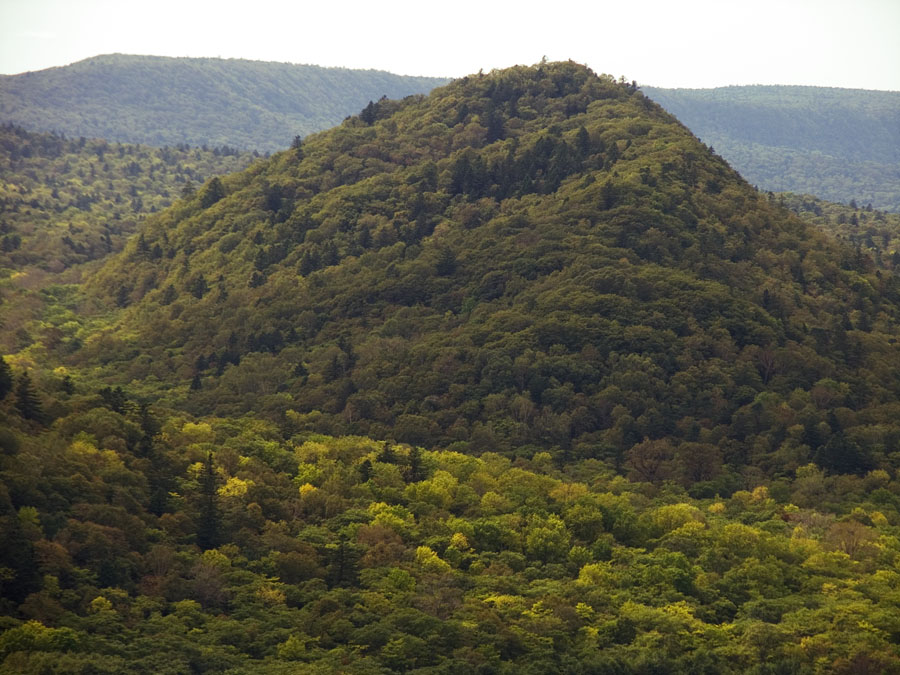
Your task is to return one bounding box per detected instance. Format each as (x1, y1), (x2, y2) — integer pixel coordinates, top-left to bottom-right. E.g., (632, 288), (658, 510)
(0, 54), (447, 152)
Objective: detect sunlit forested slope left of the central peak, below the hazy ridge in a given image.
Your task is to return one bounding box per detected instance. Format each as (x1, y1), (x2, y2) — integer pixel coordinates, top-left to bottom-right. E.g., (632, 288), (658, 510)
(0, 125), (259, 352)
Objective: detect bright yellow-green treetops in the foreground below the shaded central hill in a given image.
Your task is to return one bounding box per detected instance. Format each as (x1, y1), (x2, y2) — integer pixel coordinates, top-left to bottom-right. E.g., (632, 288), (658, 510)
(0, 410), (900, 675)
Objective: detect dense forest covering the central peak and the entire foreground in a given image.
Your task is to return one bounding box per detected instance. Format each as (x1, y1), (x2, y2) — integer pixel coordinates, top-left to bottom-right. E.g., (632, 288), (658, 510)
(0, 62), (900, 674)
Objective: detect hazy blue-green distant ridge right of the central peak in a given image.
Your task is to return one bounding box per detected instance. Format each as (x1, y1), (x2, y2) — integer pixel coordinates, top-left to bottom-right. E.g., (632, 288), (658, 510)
(643, 86), (900, 212)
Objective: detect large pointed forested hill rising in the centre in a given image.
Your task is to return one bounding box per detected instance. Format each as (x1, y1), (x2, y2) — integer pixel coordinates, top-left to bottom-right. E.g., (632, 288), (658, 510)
(72, 64), (900, 484)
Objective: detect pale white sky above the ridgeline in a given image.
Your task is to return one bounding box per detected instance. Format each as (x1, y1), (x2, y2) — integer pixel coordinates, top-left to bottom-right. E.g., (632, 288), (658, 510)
(0, 0), (900, 91)
